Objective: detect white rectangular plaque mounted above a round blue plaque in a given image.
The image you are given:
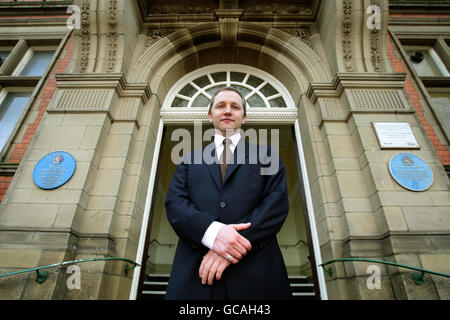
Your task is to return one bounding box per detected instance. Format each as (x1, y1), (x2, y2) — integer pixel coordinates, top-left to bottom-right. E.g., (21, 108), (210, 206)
(372, 122), (420, 149)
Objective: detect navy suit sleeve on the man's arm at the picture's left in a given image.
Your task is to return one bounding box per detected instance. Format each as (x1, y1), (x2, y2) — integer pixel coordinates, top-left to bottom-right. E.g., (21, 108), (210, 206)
(165, 157), (215, 248)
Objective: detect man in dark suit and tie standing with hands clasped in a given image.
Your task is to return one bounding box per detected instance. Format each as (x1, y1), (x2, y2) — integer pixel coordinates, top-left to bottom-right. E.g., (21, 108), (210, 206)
(165, 87), (291, 300)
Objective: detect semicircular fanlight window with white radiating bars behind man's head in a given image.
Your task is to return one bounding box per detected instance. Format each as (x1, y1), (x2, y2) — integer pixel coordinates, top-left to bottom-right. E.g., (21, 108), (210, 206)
(170, 66), (288, 108)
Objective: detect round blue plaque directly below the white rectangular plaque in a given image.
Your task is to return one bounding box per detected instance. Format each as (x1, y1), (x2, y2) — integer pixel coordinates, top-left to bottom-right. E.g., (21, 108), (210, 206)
(389, 153), (433, 191)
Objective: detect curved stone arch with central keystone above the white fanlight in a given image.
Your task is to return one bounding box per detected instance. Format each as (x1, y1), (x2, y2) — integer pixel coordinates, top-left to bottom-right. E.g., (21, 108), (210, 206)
(127, 22), (332, 106)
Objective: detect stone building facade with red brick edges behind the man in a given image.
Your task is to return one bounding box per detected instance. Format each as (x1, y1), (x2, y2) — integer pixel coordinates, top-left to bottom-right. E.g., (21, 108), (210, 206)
(0, 0), (450, 299)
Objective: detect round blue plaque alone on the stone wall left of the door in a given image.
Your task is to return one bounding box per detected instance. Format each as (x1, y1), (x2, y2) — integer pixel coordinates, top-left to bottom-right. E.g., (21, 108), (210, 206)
(33, 151), (76, 190)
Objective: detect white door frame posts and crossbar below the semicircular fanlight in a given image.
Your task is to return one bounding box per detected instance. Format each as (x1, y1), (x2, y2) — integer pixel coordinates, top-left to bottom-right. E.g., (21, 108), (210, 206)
(129, 117), (328, 300)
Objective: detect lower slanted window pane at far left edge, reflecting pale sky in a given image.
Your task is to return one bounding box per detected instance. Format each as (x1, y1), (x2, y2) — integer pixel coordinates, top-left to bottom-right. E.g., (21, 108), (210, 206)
(0, 92), (31, 150)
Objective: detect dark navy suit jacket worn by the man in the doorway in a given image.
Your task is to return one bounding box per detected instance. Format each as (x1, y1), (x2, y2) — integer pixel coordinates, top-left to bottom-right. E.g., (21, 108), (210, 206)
(165, 139), (291, 300)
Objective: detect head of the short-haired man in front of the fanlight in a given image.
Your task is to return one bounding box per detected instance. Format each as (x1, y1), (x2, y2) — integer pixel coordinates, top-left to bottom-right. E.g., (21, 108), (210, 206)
(208, 90), (246, 137)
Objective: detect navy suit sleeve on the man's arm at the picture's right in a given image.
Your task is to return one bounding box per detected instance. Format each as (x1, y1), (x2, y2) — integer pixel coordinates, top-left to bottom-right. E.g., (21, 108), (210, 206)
(239, 150), (289, 244)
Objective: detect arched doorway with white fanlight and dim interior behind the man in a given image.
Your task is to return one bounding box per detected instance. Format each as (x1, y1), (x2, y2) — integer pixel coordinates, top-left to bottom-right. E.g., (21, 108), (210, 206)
(132, 64), (324, 298)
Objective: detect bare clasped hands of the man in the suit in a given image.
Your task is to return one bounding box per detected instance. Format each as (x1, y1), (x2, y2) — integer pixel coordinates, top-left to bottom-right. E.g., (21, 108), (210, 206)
(199, 223), (252, 285)
